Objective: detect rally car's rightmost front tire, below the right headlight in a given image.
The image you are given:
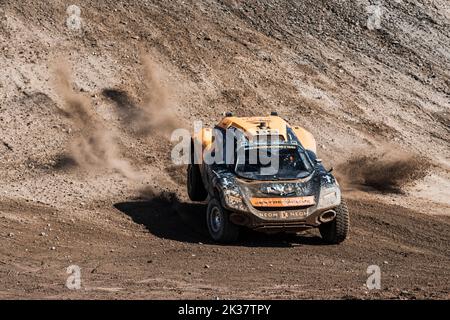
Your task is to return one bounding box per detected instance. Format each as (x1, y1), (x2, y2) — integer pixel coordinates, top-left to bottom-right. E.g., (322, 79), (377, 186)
(319, 199), (350, 244)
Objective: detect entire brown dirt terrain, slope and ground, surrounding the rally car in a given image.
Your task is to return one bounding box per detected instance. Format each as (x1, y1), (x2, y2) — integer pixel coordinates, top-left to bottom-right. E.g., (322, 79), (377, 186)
(0, 0), (450, 299)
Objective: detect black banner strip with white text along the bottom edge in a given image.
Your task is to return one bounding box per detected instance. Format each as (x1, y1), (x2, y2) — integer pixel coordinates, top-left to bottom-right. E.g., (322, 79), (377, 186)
(1, 300), (449, 319)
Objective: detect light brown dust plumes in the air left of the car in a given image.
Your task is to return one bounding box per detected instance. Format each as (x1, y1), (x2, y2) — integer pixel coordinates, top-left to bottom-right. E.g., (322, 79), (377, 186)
(55, 54), (185, 201)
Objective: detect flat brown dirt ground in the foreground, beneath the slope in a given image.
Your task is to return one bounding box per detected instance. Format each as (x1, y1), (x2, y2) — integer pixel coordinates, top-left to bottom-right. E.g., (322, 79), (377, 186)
(0, 191), (450, 299)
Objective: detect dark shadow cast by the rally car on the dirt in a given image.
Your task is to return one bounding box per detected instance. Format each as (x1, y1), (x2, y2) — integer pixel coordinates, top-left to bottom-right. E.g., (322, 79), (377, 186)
(114, 197), (326, 247)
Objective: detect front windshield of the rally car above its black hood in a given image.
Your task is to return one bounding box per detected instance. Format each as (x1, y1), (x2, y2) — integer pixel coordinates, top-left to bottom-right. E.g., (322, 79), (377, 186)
(235, 145), (313, 180)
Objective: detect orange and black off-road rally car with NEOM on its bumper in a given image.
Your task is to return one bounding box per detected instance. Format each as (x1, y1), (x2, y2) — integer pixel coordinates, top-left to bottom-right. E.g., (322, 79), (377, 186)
(187, 112), (349, 244)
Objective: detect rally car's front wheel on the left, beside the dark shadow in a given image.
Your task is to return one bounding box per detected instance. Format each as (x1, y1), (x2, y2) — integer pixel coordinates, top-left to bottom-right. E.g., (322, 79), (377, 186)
(206, 198), (239, 243)
